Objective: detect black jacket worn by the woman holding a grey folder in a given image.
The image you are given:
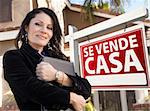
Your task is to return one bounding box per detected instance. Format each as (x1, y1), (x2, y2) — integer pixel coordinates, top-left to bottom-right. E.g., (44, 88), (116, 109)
(3, 44), (91, 111)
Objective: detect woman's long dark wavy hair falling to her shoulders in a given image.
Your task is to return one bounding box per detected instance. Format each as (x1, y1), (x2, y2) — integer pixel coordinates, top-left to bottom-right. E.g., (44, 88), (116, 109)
(15, 7), (68, 59)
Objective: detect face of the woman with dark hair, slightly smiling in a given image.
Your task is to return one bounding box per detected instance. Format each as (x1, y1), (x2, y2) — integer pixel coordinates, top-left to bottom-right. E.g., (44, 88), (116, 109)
(27, 13), (53, 51)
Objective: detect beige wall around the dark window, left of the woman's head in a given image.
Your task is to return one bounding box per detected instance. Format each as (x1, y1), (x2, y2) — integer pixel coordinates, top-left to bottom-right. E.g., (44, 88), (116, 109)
(0, 0), (31, 56)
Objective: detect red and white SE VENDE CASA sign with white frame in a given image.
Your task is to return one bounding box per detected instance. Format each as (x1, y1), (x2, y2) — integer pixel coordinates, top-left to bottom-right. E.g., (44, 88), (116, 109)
(79, 25), (149, 88)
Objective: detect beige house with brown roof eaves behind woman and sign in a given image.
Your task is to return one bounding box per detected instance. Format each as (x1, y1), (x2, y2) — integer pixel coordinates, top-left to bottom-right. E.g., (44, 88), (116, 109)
(0, 0), (150, 110)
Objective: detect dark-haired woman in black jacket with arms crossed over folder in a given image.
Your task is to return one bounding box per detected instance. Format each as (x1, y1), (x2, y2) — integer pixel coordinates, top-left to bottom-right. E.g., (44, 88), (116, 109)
(3, 8), (91, 111)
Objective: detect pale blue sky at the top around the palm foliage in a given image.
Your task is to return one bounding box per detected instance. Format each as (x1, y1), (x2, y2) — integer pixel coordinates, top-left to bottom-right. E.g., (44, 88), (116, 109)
(70, 0), (150, 12)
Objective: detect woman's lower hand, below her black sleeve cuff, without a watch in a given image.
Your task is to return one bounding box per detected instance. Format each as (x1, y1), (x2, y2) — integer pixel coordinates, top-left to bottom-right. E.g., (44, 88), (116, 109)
(70, 92), (86, 111)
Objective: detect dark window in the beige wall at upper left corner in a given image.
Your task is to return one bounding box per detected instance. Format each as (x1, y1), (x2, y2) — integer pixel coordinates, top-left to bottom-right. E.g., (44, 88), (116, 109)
(0, 0), (12, 22)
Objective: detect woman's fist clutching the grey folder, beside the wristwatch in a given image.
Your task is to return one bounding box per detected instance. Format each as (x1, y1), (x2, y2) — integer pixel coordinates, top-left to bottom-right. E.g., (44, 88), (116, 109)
(36, 62), (57, 81)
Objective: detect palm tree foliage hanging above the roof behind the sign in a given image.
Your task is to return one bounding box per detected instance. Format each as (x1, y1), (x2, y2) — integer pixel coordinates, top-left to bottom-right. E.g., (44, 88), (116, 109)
(83, 0), (129, 22)
